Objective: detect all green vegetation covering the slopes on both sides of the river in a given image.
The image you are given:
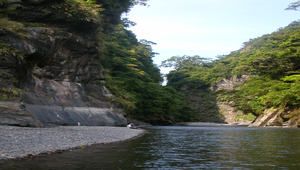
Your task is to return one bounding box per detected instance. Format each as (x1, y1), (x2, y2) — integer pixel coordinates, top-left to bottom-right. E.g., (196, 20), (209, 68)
(0, 0), (300, 124)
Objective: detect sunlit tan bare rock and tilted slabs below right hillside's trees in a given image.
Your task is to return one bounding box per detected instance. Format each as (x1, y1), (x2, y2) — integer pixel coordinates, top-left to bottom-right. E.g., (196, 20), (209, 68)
(210, 75), (300, 127)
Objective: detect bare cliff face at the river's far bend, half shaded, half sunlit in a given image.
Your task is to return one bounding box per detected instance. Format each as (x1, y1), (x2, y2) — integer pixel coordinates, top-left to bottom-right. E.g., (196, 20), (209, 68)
(181, 75), (254, 125)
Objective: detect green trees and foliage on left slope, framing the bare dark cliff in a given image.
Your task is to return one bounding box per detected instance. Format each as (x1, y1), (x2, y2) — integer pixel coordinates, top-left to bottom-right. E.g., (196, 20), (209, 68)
(0, 0), (191, 124)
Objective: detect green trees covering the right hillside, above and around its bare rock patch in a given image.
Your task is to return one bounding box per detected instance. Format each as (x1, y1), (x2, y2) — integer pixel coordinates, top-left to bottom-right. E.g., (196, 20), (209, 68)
(162, 20), (300, 119)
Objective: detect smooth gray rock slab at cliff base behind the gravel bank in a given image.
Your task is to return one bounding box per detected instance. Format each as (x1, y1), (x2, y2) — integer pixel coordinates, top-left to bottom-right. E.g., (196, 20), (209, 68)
(26, 104), (127, 126)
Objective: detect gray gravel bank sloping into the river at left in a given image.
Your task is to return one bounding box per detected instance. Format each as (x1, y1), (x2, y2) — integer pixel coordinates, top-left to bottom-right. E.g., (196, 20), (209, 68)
(0, 126), (144, 160)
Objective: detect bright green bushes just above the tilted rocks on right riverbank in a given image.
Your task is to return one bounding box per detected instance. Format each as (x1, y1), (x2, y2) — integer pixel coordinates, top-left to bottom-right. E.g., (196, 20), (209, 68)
(237, 76), (300, 115)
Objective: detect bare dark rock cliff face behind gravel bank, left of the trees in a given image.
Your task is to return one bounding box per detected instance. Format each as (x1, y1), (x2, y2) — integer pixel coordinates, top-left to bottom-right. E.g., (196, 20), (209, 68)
(0, 12), (127, 126)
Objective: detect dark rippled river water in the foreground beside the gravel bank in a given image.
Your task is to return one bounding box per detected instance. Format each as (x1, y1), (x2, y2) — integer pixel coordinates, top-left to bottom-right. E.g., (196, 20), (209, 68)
(0, 126), (300, 170)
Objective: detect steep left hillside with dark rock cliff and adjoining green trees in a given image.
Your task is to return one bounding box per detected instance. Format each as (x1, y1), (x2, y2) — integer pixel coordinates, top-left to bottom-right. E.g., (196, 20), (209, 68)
(0, 0), (189, 127)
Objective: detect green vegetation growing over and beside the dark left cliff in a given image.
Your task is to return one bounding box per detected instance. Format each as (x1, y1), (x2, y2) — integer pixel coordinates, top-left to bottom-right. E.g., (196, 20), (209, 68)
(0, 0), (191, 124)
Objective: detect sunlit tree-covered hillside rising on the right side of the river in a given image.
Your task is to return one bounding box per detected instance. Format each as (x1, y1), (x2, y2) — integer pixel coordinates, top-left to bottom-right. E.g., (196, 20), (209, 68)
(162, 21), (300, 126)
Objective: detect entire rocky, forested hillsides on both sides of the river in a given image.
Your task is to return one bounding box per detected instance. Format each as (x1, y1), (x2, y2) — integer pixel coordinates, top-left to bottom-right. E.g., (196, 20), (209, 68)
(0, 0), (300, 127)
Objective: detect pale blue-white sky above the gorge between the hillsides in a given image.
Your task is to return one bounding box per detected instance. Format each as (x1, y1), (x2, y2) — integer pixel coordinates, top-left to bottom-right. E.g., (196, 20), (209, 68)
(124, 0), (300, 74)
